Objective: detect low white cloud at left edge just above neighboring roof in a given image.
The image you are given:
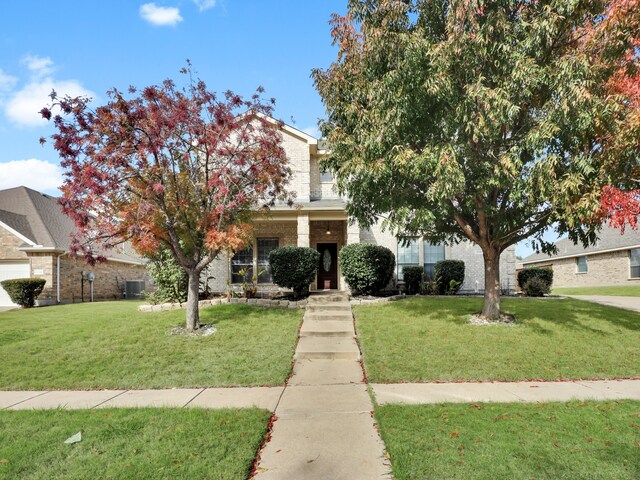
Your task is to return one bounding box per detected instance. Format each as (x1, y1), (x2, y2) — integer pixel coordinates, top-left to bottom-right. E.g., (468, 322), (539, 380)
(0, 158), (62, 194)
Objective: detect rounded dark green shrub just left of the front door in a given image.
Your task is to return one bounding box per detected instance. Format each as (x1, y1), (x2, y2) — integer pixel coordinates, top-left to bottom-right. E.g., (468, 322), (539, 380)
(269, 247), (320, 297)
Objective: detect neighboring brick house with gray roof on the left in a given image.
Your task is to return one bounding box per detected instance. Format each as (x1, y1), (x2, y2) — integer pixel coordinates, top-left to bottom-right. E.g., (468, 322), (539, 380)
(0, 187), (146, 306)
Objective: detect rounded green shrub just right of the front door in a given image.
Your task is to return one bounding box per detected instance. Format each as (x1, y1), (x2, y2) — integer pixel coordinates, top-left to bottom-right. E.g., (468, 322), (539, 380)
(338, 243), (396, 295)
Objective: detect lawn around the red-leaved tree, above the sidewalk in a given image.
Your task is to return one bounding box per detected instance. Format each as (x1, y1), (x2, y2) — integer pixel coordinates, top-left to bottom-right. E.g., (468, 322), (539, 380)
(0, 301), (301, 390)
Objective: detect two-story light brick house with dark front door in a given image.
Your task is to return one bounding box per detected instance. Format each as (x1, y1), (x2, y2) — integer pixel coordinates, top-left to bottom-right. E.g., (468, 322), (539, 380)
(206, 121), (515, 293)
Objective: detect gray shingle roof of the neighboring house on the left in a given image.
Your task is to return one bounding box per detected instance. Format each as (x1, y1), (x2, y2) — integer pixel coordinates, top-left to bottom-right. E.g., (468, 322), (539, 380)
(0, 187), (141, 263)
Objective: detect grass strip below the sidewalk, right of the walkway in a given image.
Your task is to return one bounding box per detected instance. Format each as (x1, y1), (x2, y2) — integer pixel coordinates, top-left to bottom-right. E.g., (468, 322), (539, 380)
(376, 401), (640, 480)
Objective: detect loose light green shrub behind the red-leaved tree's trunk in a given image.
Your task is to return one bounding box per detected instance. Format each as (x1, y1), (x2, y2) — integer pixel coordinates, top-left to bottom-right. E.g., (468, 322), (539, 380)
(146, 248), (189, 303)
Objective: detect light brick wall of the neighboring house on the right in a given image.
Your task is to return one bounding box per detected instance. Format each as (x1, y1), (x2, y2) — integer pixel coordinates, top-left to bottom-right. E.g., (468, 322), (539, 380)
(524, 250), (640, 288)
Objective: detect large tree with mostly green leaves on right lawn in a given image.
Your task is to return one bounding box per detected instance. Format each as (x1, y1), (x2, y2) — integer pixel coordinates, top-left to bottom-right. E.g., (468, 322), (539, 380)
(313, 0), (640, 319)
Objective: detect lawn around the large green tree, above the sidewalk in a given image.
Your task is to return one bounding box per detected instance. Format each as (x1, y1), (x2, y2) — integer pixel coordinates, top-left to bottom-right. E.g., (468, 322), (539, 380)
(354, 297), (640, 383)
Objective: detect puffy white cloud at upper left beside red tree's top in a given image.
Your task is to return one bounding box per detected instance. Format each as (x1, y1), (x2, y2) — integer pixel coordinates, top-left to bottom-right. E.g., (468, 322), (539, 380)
(5, 78), (95, 127)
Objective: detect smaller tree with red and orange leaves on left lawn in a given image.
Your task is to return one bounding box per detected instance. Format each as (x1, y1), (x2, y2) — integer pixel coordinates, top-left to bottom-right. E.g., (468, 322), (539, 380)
(41, 69), (290, 330)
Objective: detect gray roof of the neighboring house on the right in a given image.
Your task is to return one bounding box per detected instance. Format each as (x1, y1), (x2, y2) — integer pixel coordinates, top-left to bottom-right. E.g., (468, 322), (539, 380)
(523, 224), (640, 264)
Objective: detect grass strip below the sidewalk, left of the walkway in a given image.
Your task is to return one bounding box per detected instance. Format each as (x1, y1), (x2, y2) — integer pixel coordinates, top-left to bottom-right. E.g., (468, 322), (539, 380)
(0, 408), (270, 480)
